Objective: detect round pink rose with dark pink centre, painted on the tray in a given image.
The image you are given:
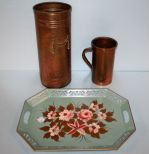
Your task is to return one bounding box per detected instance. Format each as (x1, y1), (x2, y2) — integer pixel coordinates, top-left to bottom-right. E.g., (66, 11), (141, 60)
(77, 109), (93, 121)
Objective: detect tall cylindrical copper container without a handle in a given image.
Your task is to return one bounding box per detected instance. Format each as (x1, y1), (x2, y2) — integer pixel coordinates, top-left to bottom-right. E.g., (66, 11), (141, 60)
(33, 2), (71, 88)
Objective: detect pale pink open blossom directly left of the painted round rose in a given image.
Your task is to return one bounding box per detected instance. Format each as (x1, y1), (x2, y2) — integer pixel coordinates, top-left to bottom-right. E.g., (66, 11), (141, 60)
(59, 109), (74, 121)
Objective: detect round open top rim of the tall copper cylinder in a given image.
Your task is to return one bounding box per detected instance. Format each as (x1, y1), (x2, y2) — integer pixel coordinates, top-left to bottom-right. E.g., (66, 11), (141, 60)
(33, 2), (72, 13)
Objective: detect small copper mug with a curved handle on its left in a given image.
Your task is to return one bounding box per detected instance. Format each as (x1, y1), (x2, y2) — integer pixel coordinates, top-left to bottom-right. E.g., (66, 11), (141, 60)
(82, 37), (118, 86)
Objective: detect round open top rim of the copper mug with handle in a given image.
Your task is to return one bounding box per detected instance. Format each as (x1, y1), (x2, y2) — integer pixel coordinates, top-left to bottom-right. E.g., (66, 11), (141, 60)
(91, 36), (118, 49)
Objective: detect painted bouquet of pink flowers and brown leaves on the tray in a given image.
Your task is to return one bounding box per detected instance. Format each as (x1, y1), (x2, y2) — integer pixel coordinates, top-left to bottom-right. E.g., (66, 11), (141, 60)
(37, 100), (116, 142)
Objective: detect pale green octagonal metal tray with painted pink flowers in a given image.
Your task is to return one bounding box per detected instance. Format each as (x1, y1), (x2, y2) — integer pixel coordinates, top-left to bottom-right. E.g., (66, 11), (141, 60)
(17, 89), (135, 151)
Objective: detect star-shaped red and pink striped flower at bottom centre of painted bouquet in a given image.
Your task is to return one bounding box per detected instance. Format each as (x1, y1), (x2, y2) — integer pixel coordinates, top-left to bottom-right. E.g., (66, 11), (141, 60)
(68, 121), (86, 135)
